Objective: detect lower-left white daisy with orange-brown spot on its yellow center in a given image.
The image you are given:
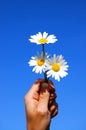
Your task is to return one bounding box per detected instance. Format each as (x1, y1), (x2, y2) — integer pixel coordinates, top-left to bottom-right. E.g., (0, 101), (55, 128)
(28, 53), (49, 74)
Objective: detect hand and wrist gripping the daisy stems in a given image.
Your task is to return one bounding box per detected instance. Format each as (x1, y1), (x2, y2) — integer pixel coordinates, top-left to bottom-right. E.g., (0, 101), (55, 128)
(24, 79), (58, 130)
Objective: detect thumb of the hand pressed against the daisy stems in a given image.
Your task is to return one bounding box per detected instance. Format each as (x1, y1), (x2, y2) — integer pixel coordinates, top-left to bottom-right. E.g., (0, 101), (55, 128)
(38, 83), (50, 112)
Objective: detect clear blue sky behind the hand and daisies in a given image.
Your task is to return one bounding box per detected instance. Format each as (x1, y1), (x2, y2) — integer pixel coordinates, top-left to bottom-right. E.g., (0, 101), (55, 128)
(0, 0), (86, 130)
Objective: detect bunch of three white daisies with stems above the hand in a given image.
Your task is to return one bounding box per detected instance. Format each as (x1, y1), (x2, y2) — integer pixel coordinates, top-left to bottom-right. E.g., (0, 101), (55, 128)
(28, 32), (68, 81)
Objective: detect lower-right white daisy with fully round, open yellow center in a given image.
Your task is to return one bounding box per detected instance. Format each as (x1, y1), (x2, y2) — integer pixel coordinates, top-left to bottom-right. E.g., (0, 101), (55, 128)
(46, 54), (68, 81)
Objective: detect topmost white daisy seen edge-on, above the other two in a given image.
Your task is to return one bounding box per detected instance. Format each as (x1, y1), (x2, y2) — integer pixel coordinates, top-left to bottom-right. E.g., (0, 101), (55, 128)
(29, 32), (58, 44)
